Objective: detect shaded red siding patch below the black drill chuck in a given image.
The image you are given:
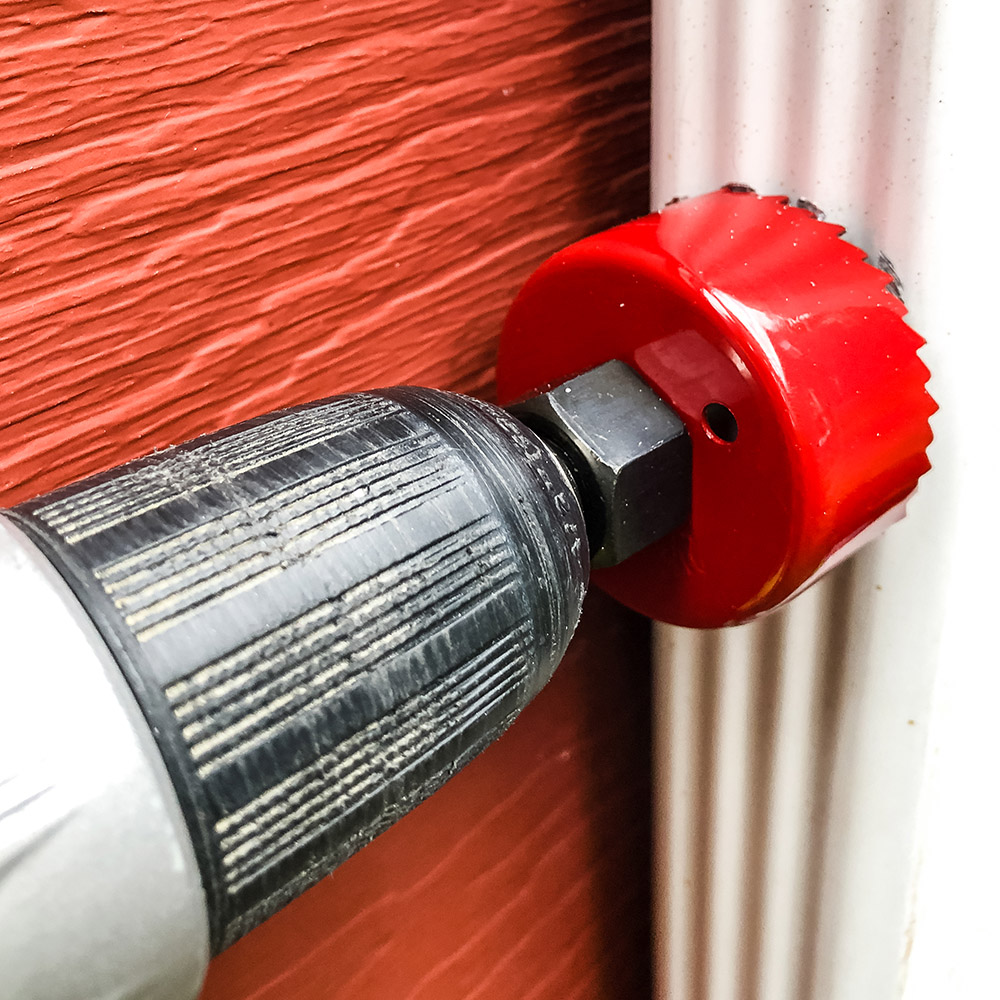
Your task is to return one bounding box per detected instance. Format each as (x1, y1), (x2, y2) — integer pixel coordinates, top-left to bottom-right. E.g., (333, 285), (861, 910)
(203, 594), (650, 1000)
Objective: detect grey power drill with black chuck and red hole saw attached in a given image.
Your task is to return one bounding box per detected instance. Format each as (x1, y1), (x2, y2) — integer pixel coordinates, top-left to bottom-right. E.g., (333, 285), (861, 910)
(0, 186), (933, 1000)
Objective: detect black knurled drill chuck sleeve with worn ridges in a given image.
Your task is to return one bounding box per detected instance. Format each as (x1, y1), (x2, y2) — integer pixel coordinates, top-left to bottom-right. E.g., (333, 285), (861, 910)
(1, 388), (589, 952)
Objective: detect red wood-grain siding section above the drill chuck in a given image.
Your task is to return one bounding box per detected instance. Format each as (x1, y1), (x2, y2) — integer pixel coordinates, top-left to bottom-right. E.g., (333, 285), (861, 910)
(0, 0), (649, 503)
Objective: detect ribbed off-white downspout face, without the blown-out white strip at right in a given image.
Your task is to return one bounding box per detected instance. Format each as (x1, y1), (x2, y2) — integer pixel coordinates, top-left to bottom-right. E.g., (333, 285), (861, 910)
(653, 0), (943, 1000)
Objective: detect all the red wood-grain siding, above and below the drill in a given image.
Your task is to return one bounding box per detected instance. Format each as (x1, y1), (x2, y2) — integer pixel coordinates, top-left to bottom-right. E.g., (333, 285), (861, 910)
(0, 0), (649, 1000)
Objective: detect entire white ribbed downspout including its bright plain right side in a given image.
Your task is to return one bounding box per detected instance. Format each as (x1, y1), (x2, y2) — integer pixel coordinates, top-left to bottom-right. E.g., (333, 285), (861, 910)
(652, 0), (1000, 1000)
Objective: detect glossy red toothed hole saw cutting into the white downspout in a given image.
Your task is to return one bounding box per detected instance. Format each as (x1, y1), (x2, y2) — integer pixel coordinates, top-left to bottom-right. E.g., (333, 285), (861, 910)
(497, 189), (936, 628)
